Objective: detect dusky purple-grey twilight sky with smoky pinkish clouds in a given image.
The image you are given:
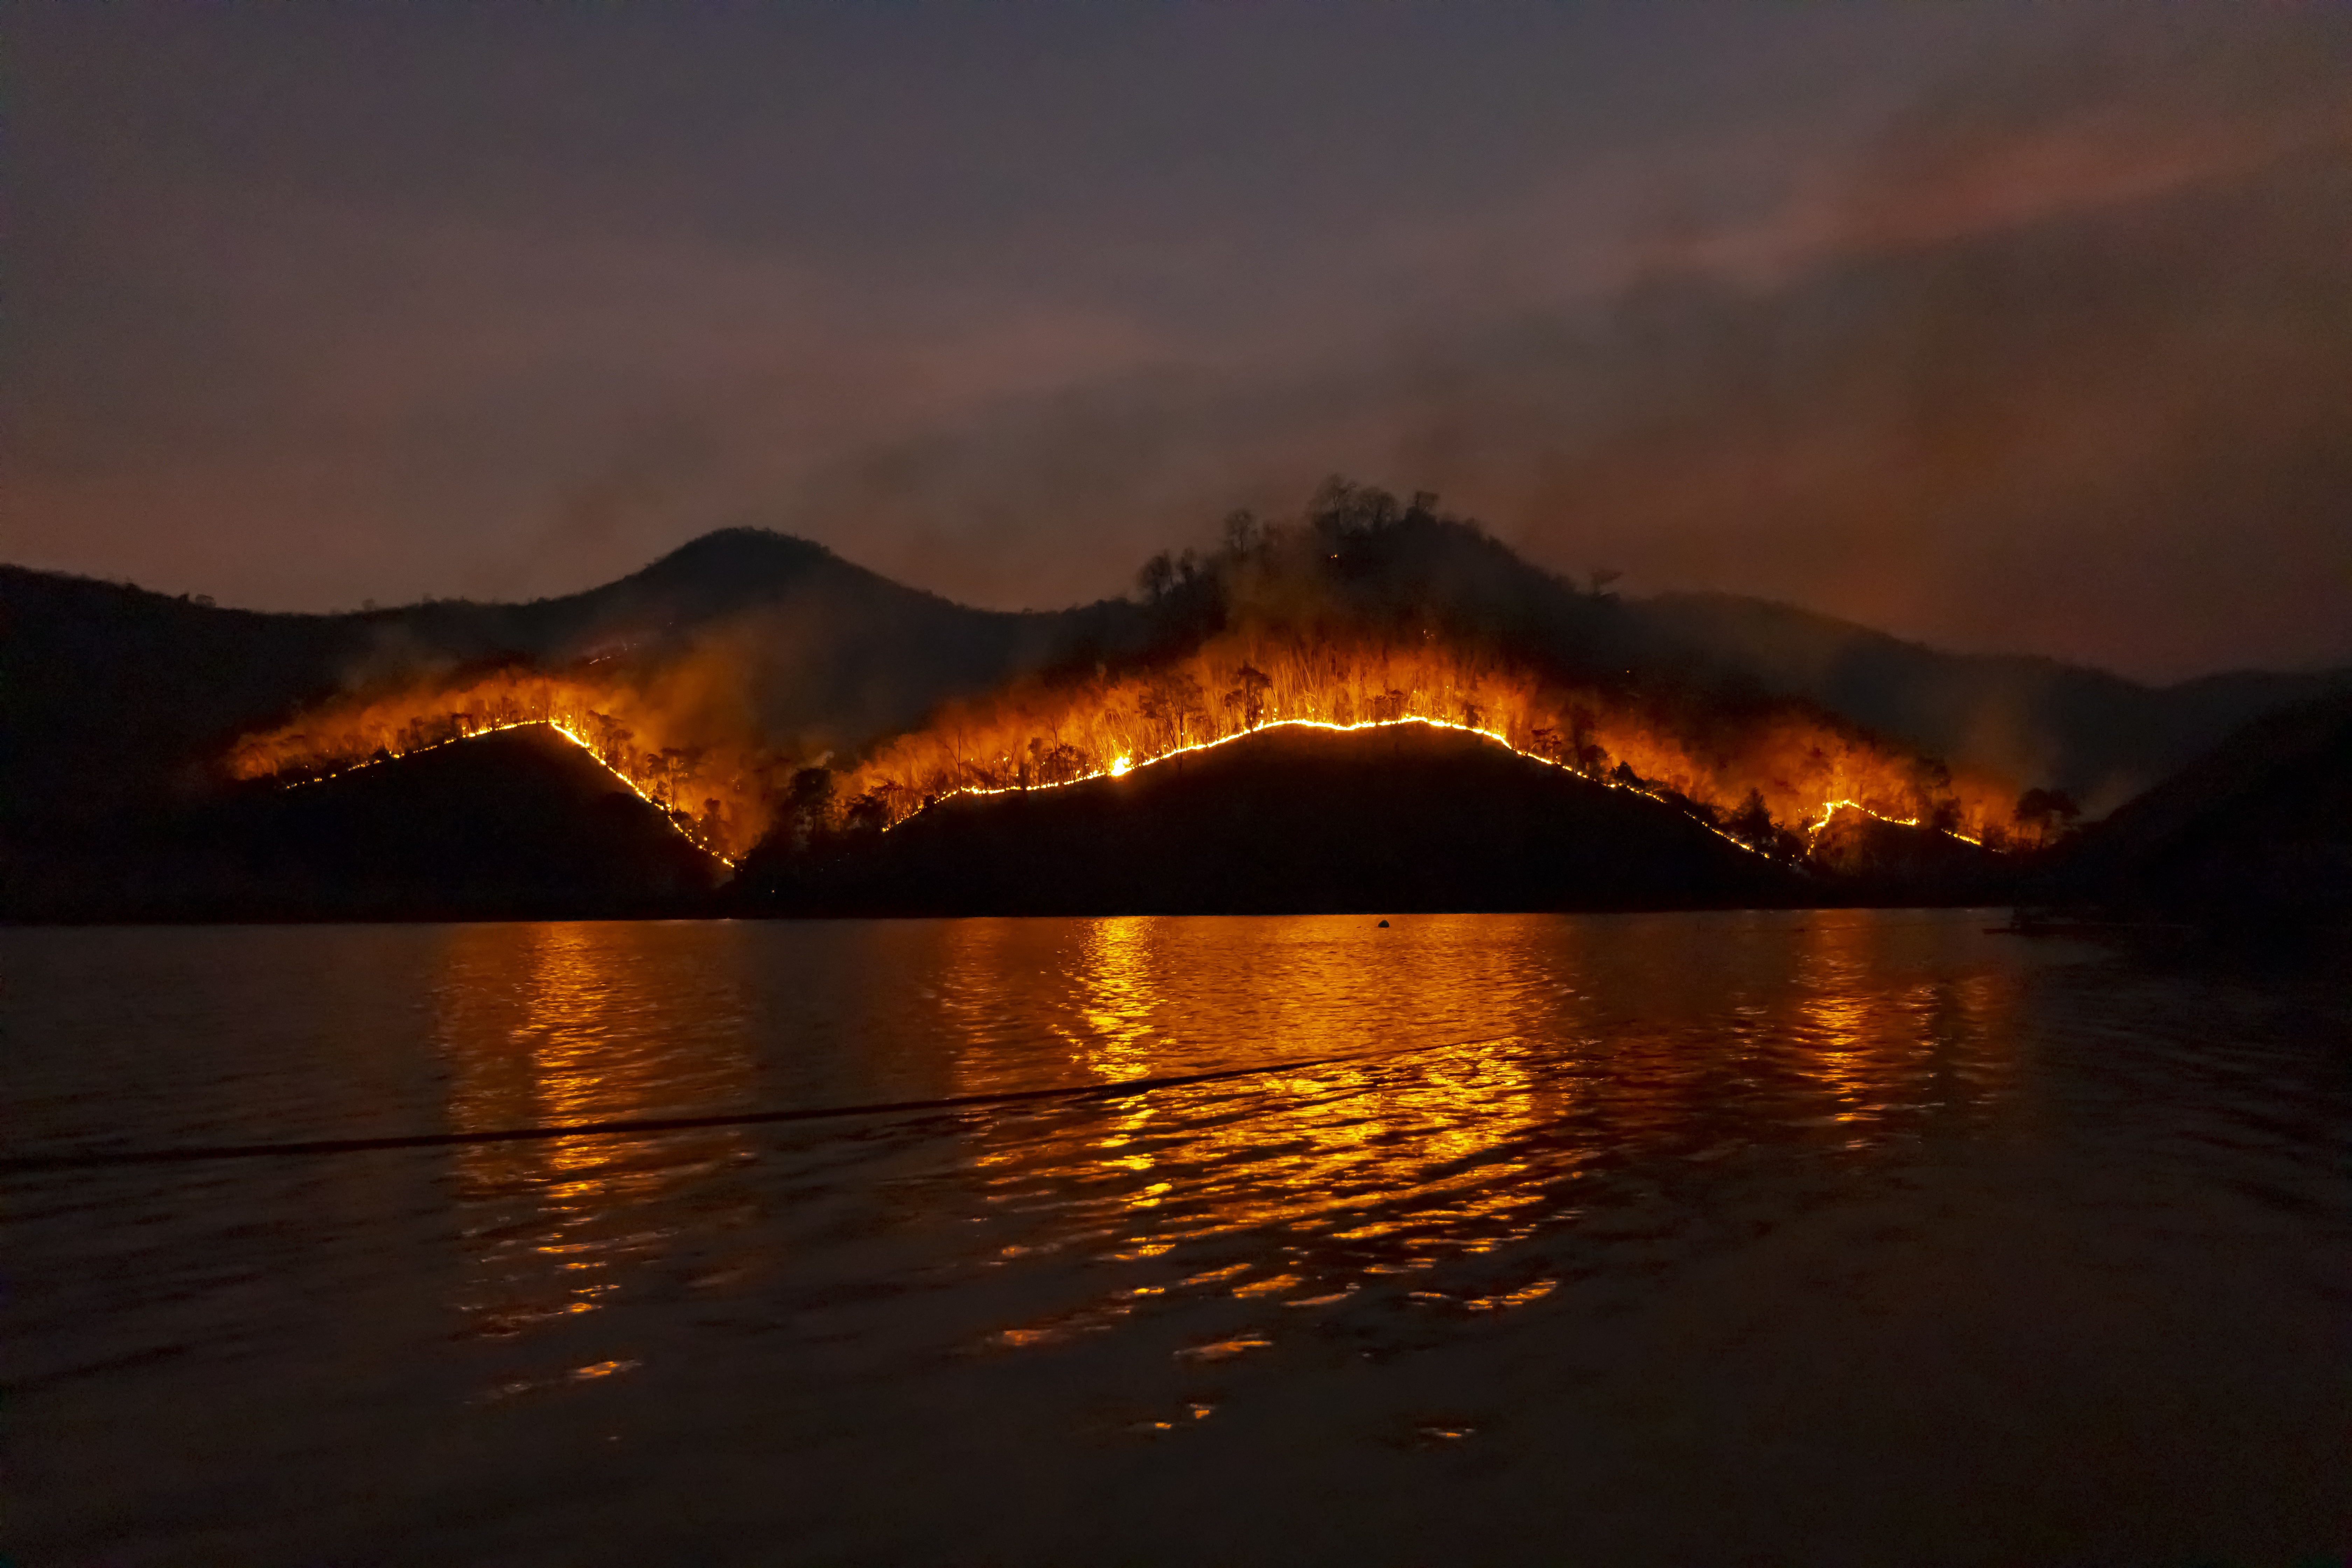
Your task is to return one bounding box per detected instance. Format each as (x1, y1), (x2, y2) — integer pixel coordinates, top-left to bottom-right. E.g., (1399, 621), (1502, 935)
(0, 0), (2352, 679)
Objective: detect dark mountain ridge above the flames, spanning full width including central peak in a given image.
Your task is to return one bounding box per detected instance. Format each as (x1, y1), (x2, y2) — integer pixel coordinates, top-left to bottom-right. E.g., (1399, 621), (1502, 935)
(0, 493), (2345, 910)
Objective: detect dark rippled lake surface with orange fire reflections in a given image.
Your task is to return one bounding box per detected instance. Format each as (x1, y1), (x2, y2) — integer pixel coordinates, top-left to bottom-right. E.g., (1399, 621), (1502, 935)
(0, 912), (2352, 1563)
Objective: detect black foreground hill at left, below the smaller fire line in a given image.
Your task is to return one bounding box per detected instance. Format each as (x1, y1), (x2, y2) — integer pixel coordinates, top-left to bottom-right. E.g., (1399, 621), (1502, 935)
(0, 729), (727, 919)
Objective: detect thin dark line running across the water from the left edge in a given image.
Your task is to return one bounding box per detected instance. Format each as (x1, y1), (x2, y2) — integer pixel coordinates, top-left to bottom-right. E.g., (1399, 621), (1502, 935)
(0, 1034), (1510, 1175)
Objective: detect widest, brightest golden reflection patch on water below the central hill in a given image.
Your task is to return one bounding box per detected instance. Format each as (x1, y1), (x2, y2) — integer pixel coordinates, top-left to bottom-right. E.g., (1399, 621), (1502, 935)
(950, 919), (1567, 1316)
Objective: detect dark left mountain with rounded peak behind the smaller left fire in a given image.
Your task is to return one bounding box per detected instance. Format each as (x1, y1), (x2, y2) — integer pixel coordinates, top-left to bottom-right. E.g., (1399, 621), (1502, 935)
(0, 529), (1134, 846)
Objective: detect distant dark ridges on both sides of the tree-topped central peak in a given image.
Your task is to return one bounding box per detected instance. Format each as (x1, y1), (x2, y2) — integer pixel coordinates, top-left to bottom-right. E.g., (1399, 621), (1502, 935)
(0, 522), (2352, 846)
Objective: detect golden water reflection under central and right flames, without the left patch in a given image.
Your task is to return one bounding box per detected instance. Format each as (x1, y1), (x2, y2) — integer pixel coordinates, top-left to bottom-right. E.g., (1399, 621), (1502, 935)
(960, 915), (2032, 1345)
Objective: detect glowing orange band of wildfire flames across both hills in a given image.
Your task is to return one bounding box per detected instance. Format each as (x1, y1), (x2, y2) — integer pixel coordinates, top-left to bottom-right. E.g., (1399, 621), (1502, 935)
(228, 628), (2016, 865)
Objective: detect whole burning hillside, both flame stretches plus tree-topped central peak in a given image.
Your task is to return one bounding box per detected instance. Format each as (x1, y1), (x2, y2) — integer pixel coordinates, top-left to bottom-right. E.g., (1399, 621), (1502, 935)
(231, 484), (2030, 860)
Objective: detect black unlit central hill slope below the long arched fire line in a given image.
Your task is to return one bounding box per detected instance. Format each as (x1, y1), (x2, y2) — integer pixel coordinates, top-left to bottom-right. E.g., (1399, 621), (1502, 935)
(732, 724), (1816, 915)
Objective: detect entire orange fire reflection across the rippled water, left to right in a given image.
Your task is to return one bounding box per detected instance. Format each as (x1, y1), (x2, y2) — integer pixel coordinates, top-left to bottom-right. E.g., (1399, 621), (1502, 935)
(400, 915), (2016, 1387)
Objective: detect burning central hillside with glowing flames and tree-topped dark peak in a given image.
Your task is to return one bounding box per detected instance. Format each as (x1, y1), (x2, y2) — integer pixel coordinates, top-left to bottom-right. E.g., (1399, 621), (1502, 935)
(811, 486), (2018, 853)
